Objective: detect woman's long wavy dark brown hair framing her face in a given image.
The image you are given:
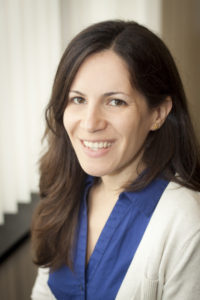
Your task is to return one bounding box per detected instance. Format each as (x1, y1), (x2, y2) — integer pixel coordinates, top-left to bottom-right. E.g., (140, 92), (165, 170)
(32, 20), (200, 269)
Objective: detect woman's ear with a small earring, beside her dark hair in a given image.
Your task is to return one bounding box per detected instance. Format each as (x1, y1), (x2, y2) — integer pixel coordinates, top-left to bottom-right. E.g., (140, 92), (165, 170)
(150, 96), (172, 131)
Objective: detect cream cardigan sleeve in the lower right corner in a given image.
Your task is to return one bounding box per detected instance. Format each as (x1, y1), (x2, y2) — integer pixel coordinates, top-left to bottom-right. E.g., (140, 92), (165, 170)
(162, 230), (200, 300)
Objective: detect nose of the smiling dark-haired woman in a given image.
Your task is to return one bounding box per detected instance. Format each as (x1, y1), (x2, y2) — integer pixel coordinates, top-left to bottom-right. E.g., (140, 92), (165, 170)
(81, 104), (107, 132)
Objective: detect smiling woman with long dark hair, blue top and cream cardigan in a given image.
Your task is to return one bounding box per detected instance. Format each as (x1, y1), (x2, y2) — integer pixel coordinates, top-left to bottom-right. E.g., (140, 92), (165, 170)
(32, 21), (200, 300)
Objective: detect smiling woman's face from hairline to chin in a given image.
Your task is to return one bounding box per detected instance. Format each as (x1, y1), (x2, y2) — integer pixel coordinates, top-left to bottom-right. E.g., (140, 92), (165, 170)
(63, 50), (156, 177)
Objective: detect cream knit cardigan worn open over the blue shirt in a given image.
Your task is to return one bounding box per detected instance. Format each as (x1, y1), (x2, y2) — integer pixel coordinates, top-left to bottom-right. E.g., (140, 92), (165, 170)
(32, 182), (200, 300)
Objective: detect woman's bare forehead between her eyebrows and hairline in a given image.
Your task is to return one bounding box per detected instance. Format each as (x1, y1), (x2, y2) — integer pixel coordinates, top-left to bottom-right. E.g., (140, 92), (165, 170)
(71, 50), (132, 91)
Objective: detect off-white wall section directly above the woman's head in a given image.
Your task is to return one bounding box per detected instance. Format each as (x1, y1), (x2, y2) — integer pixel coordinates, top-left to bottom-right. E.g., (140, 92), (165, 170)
(60, 0), (162, 49)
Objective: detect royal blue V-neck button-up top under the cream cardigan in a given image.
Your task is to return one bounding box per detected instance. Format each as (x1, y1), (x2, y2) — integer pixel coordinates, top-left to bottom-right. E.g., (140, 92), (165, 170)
(48, 177), (168, 300)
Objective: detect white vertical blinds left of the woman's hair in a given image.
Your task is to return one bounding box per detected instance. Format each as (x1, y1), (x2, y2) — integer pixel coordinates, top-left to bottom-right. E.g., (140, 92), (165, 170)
(0, 0), (61, 224)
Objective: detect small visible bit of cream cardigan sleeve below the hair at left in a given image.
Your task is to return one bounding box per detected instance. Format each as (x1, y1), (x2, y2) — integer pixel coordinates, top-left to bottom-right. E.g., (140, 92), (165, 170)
(31, 268), (56, 300)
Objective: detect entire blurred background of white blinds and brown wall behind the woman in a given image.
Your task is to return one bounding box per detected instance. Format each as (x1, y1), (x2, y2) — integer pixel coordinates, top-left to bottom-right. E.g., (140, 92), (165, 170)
(0, 0), (200, 300)
